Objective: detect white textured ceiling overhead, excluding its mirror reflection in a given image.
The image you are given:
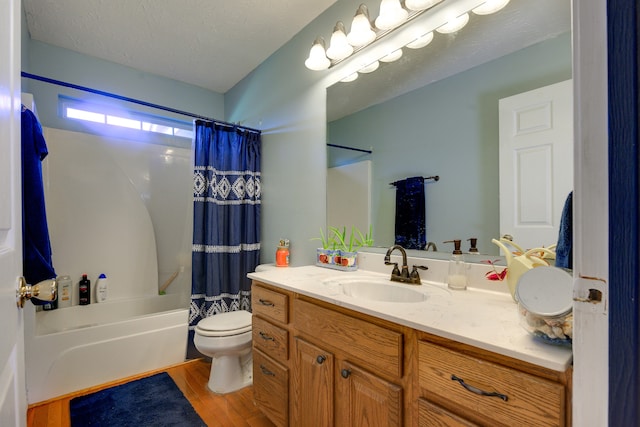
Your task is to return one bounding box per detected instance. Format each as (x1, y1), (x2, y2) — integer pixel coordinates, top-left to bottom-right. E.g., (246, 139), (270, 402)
(23, 0), (336, 93)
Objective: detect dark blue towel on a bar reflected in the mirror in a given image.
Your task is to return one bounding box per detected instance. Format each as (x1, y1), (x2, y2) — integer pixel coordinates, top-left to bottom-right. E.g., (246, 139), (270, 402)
(395, 176), (427, 249)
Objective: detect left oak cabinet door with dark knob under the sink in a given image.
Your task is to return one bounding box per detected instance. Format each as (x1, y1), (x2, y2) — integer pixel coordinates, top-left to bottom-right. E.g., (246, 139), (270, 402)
(292, 338), (334, 426)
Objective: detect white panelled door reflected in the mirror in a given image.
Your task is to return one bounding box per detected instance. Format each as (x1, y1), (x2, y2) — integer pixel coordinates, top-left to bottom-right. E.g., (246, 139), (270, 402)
(499, 80), (573, 248)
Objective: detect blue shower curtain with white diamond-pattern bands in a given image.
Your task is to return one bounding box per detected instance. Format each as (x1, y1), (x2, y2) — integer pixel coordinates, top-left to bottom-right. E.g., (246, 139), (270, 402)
(189, 120), (261, 330)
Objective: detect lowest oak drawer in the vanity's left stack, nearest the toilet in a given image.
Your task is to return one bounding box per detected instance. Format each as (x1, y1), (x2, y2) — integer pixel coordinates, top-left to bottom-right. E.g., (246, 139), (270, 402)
(253, 350), (289, 427)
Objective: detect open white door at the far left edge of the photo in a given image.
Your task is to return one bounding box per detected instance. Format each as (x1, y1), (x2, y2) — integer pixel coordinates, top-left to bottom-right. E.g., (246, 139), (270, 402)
(0, 0), (27, 427)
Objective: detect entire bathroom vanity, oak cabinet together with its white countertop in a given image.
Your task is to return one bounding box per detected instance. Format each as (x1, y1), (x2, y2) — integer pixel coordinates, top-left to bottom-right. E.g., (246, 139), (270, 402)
(249, 266), (572, 426)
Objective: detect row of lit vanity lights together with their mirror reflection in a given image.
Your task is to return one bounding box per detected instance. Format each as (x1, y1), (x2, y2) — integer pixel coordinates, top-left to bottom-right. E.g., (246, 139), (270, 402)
(305, 0), (510, 82)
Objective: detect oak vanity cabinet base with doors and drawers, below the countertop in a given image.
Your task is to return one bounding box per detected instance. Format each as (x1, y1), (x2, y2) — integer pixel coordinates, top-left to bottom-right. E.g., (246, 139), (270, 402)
(252, 281), (572, 427)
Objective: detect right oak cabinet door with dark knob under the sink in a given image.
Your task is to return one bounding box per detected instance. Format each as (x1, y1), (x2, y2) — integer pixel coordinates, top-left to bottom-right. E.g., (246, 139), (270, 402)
(336, 362), (402, 427)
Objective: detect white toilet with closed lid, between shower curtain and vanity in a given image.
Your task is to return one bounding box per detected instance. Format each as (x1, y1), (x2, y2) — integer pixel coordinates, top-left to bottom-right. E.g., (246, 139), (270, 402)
(193, 310), (253, 394)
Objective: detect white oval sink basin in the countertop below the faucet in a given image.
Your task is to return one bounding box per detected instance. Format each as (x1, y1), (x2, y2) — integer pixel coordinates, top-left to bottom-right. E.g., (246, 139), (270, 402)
(324, 279), (427, 303)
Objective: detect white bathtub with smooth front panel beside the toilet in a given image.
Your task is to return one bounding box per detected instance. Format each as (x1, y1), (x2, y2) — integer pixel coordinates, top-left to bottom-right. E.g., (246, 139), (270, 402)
(24, 294), (189, 404)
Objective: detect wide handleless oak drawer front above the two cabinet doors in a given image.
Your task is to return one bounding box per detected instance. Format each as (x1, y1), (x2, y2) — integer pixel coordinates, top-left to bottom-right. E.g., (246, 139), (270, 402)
(293, 299), (403, 378)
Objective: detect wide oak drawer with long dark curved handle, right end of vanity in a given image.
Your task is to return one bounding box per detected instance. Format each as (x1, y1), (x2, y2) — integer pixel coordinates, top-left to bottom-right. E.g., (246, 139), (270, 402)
(418, 341), (565, 426)
